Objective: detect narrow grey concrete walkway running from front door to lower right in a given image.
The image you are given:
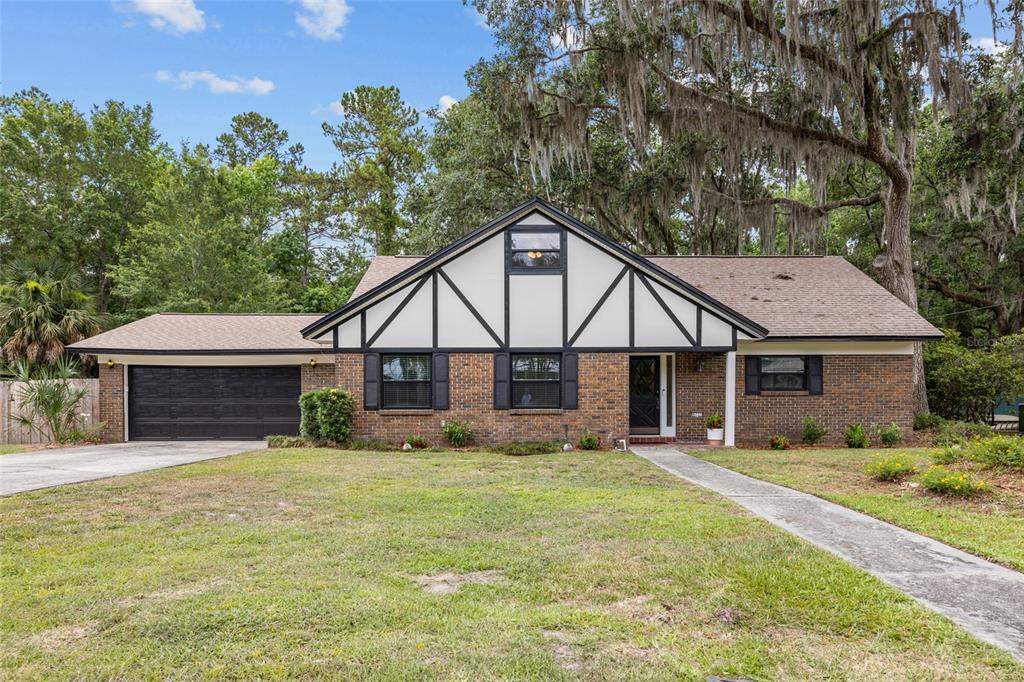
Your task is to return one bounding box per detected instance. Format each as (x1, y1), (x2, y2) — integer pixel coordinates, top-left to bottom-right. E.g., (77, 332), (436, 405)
(632, 446), (1024, 662)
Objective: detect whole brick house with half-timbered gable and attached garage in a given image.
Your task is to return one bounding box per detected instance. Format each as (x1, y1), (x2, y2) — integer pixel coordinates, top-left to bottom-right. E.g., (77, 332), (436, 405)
(70, 199), (941, 444)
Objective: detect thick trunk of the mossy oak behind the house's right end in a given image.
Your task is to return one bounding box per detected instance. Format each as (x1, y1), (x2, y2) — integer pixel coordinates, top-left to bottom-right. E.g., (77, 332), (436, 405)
(874, 165), (928, 413)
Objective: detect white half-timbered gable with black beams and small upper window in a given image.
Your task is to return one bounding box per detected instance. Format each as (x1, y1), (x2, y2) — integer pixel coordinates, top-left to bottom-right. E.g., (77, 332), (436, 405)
(303, 195), (765, 351)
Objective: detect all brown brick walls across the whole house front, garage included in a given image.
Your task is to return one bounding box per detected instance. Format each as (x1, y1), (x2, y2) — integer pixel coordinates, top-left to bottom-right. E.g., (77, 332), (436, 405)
(98, 353), (913, 446)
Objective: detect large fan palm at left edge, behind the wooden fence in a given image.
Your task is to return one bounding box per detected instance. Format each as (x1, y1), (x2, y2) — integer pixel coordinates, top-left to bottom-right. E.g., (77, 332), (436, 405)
(0, 264), (100, 366)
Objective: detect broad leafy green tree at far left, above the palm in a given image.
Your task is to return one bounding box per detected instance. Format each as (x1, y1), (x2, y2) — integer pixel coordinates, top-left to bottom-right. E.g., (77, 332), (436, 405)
(0, 89), (169, 312)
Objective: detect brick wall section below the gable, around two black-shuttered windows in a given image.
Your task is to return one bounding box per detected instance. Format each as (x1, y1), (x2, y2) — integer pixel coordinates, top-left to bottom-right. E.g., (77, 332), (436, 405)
(335, 353), (629, 444)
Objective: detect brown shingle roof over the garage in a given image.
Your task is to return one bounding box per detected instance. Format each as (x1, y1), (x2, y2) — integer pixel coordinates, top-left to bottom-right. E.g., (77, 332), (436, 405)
(69, 312), (325, 352)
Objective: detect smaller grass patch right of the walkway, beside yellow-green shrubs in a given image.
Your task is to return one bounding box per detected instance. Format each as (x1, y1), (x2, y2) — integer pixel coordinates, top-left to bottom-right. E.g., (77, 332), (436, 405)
(692, 449), (1024, 570)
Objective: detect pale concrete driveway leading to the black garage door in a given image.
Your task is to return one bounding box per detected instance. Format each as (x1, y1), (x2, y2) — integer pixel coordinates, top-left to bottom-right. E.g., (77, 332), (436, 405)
(0, 440), (266, 495)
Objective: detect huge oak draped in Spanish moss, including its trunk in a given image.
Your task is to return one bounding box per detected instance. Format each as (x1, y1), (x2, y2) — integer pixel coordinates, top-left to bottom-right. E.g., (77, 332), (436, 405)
(468, 0), (1020, 410)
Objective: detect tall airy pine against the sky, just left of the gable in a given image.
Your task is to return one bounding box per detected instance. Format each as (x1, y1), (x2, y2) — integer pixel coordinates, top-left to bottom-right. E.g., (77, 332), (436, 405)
(324, 85), (425, 255)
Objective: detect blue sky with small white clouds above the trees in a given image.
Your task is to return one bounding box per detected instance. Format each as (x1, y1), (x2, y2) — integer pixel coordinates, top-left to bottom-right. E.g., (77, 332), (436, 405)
(0, 0), (1009, 169)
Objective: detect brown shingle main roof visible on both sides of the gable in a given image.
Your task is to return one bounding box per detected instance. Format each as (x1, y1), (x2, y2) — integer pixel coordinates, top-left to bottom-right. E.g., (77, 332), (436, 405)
(352, 256), (941, 338)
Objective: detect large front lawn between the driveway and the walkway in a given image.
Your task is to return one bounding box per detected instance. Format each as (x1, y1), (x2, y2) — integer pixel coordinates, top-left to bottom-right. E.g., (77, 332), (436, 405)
(0, 450), (1024, 681)
